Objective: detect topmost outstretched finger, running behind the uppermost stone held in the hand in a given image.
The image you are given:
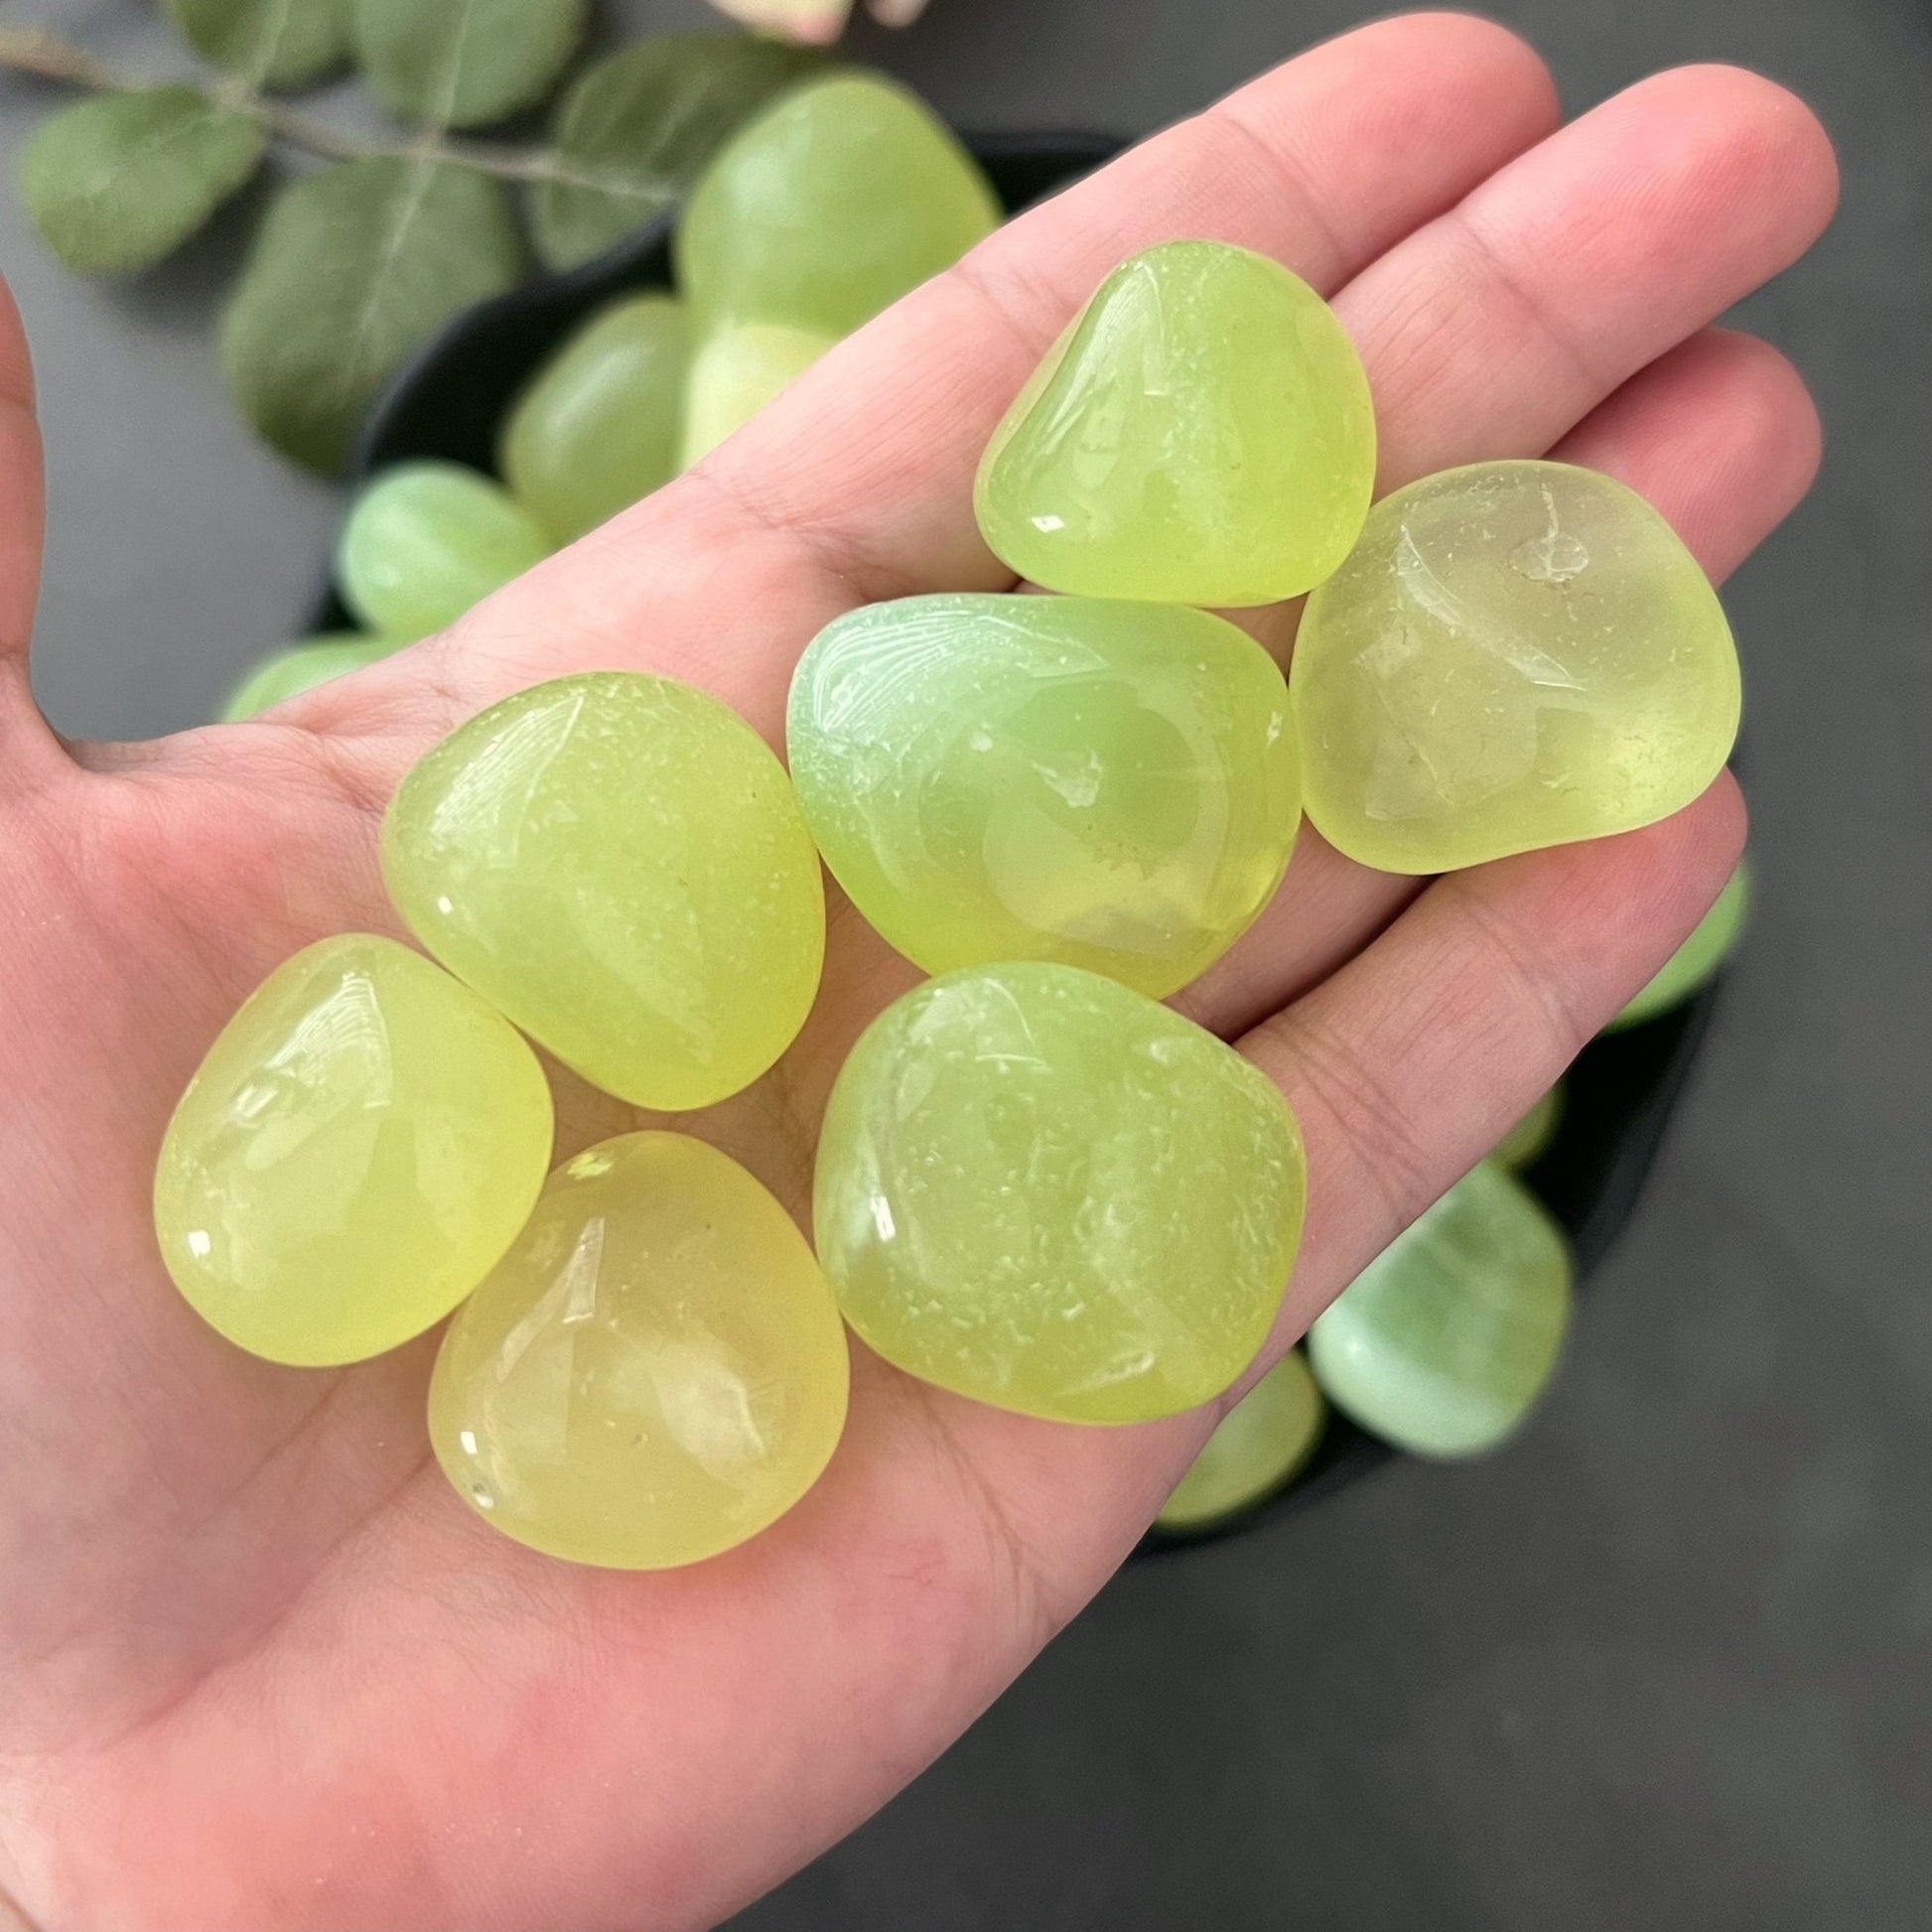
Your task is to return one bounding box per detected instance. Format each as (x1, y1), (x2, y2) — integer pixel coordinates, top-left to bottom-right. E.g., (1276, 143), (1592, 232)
(687, 14), (1557, 597)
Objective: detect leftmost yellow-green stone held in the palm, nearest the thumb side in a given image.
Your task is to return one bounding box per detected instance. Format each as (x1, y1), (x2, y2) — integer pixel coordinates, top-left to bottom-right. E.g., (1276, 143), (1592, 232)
(155, 933), (551, 1366)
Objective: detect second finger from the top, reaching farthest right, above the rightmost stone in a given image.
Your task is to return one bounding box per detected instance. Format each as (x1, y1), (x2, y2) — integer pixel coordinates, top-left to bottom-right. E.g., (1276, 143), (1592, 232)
(1339, 68), (1838, 488)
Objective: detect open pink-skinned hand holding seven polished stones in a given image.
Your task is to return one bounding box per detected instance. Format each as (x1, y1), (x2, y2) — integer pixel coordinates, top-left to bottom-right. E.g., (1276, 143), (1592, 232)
(0, 16), (1834, 1932)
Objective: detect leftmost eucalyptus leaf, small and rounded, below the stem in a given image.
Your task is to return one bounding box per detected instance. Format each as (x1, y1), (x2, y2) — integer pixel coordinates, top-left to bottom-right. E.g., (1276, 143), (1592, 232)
(16, 85), (263, 274)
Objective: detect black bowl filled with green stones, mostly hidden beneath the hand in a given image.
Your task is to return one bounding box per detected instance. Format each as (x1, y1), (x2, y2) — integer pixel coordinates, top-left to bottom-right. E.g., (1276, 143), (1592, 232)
(309, 133), (1718, 1552)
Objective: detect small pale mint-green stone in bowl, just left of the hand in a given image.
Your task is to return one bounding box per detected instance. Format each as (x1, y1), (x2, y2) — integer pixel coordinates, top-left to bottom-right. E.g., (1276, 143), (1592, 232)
(337, 462), (551, 641)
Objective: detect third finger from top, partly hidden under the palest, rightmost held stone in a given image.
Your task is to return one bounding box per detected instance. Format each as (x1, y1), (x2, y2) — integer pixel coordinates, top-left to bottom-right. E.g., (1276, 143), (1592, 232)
(1176, 329), (1820, 1034)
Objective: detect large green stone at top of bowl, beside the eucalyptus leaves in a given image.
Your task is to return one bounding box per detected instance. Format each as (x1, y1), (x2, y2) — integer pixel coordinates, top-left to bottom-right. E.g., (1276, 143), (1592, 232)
(676, 71), (1001, 337)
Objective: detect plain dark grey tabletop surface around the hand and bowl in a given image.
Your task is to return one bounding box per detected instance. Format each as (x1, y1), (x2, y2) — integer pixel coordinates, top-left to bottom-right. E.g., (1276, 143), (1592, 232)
(0, 0), (1932, 1932)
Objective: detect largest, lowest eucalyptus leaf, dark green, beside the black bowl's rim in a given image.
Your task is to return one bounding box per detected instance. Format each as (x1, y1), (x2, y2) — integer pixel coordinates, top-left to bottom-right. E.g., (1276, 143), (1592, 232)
(222, 157), (523, 470)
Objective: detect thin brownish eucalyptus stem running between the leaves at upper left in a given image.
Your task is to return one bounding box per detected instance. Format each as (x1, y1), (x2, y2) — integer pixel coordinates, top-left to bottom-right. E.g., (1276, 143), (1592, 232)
(0, 27), (674, 199)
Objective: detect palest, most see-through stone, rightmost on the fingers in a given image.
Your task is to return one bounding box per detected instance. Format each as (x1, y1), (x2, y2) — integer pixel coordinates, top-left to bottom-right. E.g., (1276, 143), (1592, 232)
(1291, 462), (1738, 874)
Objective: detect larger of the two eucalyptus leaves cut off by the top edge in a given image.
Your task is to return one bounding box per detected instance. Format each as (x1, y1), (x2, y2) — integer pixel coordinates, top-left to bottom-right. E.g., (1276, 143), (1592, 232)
(353, 0), (586, 127)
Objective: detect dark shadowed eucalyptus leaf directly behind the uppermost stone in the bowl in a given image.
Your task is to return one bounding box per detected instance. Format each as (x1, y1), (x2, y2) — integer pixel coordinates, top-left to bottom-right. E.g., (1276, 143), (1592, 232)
(529, 33), (819, 268)
